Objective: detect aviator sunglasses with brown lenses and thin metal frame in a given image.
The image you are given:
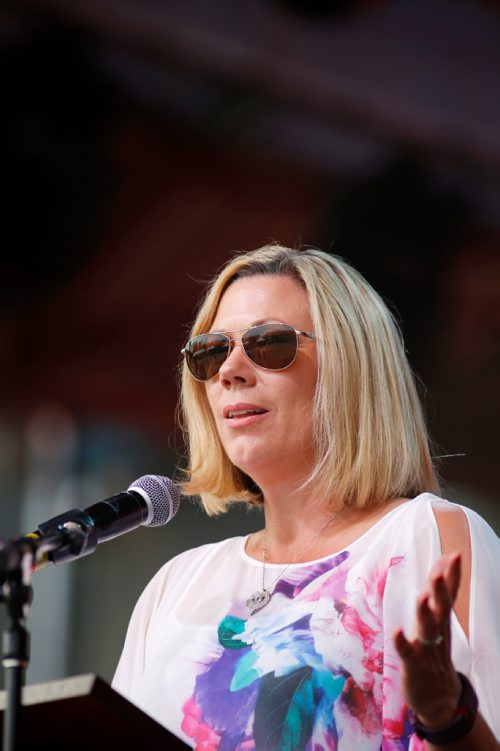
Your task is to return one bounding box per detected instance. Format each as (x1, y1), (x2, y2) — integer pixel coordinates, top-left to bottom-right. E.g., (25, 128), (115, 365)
(181, 323), (316, 381)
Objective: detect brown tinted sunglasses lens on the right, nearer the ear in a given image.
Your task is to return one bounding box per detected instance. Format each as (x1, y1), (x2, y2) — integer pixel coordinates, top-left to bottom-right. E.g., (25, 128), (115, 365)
(241, 323), (297, 370)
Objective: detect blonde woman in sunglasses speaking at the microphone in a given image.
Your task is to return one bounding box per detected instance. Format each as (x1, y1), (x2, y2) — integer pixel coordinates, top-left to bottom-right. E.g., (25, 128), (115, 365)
(114, 245), (500, 751)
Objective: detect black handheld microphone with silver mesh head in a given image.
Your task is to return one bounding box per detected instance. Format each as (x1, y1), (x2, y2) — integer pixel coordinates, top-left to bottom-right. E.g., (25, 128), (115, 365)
(0, 475), (180, 578)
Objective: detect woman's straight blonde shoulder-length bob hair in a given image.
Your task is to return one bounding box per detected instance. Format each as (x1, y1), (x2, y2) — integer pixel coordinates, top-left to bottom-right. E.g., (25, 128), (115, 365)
(180, 244), (438, 515)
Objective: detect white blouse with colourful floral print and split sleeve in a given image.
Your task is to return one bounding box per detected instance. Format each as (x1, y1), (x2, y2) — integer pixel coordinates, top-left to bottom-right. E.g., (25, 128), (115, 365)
(113, 493), (500, 751)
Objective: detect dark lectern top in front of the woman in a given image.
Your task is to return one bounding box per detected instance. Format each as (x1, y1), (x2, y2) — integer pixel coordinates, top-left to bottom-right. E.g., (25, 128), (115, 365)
(0, 674), (189, 751)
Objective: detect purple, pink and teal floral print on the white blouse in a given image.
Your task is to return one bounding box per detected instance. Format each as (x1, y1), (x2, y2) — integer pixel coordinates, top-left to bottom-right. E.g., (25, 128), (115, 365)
(182, 552), (410, 751)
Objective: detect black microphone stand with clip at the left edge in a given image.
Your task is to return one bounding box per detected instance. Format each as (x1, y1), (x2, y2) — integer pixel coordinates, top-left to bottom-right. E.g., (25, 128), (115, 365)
(0, 522), (93, 751)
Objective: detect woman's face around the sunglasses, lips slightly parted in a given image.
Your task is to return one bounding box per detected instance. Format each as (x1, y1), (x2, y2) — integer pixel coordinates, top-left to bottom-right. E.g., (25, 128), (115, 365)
(206, 275), (317, 489)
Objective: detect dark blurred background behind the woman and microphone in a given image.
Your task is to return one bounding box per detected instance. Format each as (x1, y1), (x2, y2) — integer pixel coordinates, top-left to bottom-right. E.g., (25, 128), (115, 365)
(0, 0), (500, 683)
